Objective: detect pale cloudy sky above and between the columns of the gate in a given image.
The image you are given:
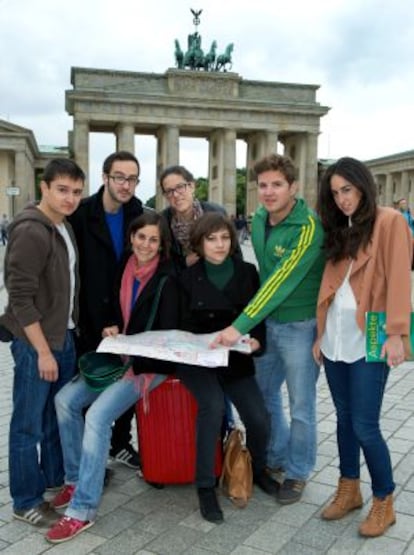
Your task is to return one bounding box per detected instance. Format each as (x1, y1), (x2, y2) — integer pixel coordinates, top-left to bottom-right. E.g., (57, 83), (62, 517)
(0, 0), (414, 200)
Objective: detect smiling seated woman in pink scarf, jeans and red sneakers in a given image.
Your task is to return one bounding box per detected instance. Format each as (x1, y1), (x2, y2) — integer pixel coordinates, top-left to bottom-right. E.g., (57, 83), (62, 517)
(46, 212), (178, 543)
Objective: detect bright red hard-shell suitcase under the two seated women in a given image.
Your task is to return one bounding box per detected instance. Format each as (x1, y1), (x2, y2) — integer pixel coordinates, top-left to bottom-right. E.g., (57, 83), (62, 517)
(136, 376), (222, 484)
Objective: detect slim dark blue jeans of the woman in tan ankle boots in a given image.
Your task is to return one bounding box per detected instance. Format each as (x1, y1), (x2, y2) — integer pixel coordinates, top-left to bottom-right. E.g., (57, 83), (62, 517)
(324, 358), (395, 497)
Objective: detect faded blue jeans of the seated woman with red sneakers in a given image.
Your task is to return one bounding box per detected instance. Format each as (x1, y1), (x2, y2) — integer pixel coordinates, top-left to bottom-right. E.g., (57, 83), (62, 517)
(55, 374), (167, 521)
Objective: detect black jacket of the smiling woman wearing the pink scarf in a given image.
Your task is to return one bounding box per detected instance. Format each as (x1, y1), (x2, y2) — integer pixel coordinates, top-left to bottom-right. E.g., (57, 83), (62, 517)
(111, 255), (179, 374)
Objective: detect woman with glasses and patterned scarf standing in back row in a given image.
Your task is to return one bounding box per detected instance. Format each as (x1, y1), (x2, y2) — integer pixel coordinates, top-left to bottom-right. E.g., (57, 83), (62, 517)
(160, 166), (230, 270)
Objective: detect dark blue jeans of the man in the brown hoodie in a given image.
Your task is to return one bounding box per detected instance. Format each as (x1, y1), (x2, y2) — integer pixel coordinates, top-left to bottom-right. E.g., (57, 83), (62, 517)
(9, 331), (76, 510)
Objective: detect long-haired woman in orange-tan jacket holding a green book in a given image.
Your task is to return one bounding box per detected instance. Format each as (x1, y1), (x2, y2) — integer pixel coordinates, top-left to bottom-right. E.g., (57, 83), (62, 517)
(313, 158), (412, 537)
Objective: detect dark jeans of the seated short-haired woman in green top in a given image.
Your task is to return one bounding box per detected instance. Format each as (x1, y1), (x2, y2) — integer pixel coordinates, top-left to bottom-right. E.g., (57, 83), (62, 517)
(176, 365), (270, 488)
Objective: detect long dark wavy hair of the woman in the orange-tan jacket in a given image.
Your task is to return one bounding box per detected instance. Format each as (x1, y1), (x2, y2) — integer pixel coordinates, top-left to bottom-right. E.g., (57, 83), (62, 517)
(317, 157), (377, 262)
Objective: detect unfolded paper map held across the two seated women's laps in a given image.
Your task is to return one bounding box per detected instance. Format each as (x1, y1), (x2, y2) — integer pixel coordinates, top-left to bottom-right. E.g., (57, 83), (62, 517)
(97, 330), (251, 368)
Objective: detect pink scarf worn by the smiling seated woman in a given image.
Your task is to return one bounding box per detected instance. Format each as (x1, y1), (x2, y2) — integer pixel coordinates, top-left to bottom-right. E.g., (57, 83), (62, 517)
(119, 254), (160, 412)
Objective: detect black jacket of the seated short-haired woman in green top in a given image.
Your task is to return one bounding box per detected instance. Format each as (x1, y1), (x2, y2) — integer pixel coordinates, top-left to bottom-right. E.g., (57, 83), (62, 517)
(180, 256), (266, 380)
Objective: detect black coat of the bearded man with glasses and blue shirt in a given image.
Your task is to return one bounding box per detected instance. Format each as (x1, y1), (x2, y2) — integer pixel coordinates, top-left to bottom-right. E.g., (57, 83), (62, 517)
(68, 186), (143, 354)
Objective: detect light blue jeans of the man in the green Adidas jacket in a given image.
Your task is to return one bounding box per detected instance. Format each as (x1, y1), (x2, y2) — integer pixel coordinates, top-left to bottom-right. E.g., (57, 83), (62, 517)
(255, 318), (319, 480)
